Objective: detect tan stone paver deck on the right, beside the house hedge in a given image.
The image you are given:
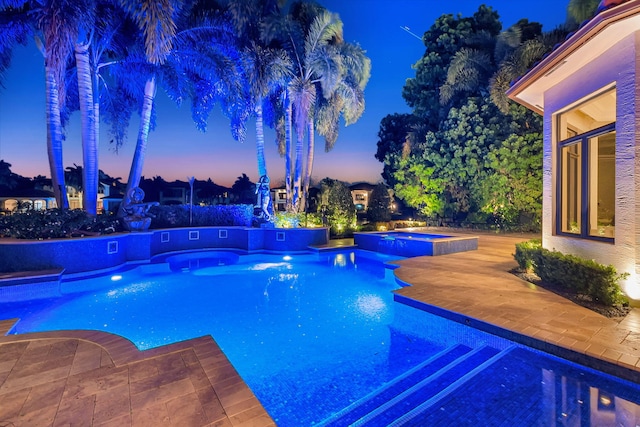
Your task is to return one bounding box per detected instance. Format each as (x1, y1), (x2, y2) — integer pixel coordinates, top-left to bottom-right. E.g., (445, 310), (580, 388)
(395, 234), (640, 379)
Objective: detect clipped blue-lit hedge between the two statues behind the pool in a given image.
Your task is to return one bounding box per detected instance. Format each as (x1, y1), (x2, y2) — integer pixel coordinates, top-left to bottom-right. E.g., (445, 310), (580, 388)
(150, 205), (253, 228)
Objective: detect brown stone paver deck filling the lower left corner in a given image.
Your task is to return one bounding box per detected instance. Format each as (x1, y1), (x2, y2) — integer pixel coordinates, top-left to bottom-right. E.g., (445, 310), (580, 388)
(0, 322), (275, 427)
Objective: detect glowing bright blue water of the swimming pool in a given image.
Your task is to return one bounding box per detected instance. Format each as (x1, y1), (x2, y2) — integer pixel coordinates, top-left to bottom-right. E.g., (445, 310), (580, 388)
(0, 251), (640, 426)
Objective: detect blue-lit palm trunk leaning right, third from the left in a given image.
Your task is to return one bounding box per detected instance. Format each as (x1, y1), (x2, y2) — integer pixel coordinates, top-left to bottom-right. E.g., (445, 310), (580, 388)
(118, 76), (156, 216)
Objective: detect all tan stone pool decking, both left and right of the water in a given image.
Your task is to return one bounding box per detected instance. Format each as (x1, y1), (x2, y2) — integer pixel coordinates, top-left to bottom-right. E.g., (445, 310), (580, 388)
(0, 234), (640, 427)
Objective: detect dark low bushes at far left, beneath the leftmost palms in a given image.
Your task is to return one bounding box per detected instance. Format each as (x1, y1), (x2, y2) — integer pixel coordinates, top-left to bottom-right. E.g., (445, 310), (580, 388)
(0, 209), (123, 240)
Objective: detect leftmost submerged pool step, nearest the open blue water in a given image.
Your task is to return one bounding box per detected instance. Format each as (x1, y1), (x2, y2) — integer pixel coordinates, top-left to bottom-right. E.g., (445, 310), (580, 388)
(319, 344), (471, 427)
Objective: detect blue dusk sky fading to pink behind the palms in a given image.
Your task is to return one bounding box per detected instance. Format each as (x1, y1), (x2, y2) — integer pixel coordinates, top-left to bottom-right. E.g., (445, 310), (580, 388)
(0, 0), (568, 186)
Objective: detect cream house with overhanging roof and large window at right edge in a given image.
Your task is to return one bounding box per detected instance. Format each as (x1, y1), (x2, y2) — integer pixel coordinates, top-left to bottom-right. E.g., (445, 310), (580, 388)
(507, 0), (640, 305)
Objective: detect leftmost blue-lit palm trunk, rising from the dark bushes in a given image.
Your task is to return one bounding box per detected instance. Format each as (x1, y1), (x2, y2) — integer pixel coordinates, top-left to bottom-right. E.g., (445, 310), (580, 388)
(45, 67), (69, 209)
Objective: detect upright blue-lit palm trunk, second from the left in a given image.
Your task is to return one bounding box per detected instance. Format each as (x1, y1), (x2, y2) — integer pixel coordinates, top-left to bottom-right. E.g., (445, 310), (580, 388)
(75, 43), (98, 216)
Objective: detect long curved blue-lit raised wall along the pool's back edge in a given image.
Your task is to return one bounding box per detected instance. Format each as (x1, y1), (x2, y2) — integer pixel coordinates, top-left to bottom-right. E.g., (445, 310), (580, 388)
(0, 227), (329, 278)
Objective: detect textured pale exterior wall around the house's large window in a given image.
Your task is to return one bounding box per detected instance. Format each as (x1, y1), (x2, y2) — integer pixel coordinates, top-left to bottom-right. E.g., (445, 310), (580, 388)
(542, 32), (640, 302)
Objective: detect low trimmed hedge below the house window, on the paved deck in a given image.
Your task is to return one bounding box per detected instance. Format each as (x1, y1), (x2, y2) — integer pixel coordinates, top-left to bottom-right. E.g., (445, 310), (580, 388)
(514, 240), (629, 306)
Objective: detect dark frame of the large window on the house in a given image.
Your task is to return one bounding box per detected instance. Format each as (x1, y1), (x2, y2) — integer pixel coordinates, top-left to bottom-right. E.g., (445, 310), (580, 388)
(555, 122), (616, 243)
